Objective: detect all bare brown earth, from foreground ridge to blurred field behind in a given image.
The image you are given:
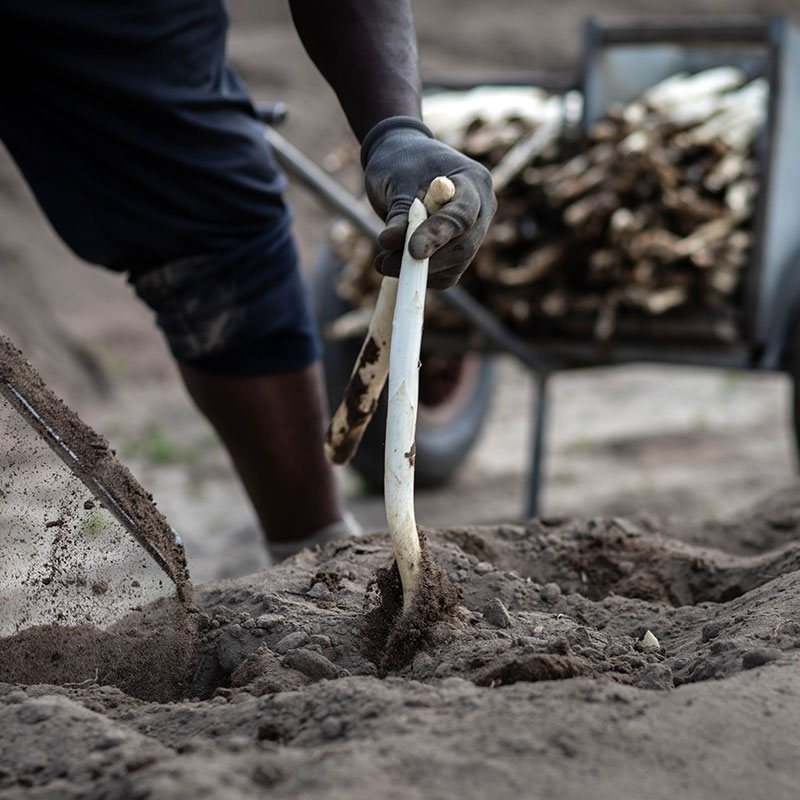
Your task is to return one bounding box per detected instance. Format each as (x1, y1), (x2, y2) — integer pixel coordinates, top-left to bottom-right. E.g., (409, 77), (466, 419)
(0, 0), (800, 800)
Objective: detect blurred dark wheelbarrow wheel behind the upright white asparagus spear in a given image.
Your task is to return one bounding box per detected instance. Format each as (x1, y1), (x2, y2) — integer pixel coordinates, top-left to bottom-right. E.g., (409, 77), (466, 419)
(311, 241), (494, 491)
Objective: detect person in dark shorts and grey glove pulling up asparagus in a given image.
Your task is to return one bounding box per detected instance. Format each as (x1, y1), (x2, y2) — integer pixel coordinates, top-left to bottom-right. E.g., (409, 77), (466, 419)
(0, 0), (495, 558)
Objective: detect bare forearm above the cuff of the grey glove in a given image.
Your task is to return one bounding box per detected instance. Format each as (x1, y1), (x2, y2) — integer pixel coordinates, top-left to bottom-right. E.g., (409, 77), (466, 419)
(289, 0), (420, 141)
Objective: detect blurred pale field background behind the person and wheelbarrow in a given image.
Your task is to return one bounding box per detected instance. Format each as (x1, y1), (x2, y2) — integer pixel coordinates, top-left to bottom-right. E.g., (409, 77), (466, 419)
(0, 0), (800, 582)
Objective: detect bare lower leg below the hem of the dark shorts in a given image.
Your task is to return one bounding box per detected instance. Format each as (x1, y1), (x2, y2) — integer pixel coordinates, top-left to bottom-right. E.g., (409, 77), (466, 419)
(179, 362), (342, 542)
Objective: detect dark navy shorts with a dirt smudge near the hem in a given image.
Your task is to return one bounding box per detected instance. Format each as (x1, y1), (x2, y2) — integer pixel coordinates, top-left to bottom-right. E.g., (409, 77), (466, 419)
(0, 0), (318, 375)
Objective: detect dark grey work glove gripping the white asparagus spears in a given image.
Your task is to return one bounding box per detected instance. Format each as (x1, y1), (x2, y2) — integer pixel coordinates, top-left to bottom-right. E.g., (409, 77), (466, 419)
(361, 117), (497, 289)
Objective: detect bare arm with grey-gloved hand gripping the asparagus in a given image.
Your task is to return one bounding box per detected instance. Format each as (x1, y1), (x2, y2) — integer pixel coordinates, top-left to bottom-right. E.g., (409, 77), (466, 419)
(290, 0), (497, 289)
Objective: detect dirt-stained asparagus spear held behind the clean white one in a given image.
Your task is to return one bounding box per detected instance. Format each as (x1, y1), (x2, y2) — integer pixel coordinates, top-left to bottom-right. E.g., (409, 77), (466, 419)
(325, 177), (455, 464)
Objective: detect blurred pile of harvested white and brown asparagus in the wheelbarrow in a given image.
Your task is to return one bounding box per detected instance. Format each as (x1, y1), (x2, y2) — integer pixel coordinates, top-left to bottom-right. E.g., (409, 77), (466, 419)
(331, 67), (768, 341)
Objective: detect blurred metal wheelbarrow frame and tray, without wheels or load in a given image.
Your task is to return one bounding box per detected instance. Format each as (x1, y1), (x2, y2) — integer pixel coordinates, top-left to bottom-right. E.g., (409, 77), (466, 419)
(260, 18), (800, 517)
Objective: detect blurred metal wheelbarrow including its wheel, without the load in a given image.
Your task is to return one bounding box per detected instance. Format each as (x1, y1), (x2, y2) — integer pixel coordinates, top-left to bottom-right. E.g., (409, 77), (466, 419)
(264, 18), (800, 517)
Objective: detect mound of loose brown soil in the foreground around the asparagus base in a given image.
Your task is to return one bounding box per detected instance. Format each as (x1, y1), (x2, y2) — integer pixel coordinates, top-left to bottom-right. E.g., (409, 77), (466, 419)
(0, 487), (800, 800)
